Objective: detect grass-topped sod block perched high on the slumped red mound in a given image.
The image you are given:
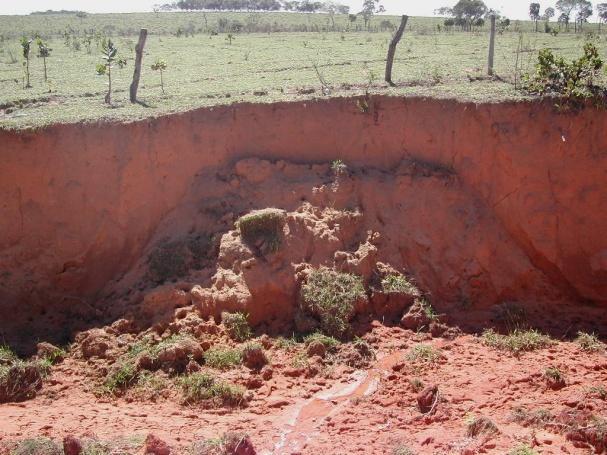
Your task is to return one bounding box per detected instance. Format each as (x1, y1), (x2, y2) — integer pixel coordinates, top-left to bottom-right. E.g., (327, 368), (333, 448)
(236, 209), (285, 253)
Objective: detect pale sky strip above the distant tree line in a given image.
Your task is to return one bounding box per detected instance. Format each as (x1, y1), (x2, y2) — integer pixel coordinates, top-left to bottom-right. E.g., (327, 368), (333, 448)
(0, 0), (600, 19)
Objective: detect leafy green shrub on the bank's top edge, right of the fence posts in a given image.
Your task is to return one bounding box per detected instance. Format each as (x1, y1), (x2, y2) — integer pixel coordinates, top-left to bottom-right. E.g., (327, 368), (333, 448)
(524, 43), (603, 99)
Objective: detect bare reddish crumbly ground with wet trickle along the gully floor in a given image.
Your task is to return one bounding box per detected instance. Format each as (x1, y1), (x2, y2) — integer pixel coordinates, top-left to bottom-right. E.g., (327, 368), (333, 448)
(0, 324), (607, 454)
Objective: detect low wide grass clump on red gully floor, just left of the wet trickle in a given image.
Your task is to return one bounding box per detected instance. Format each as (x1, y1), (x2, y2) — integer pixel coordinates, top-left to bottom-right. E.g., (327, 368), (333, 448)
(179, 373), (245, 406)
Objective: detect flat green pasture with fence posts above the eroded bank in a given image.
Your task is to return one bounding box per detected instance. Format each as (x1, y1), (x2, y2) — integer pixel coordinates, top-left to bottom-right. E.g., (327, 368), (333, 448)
(0, 13), (607, 128)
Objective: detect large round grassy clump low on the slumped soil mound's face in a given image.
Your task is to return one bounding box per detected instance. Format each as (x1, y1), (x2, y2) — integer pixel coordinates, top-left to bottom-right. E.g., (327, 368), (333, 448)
(301, 267), (366, 338)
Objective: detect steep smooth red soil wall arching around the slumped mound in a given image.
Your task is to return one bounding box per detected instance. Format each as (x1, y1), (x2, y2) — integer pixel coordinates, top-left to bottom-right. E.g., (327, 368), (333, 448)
(0, 97), (607, 344)
